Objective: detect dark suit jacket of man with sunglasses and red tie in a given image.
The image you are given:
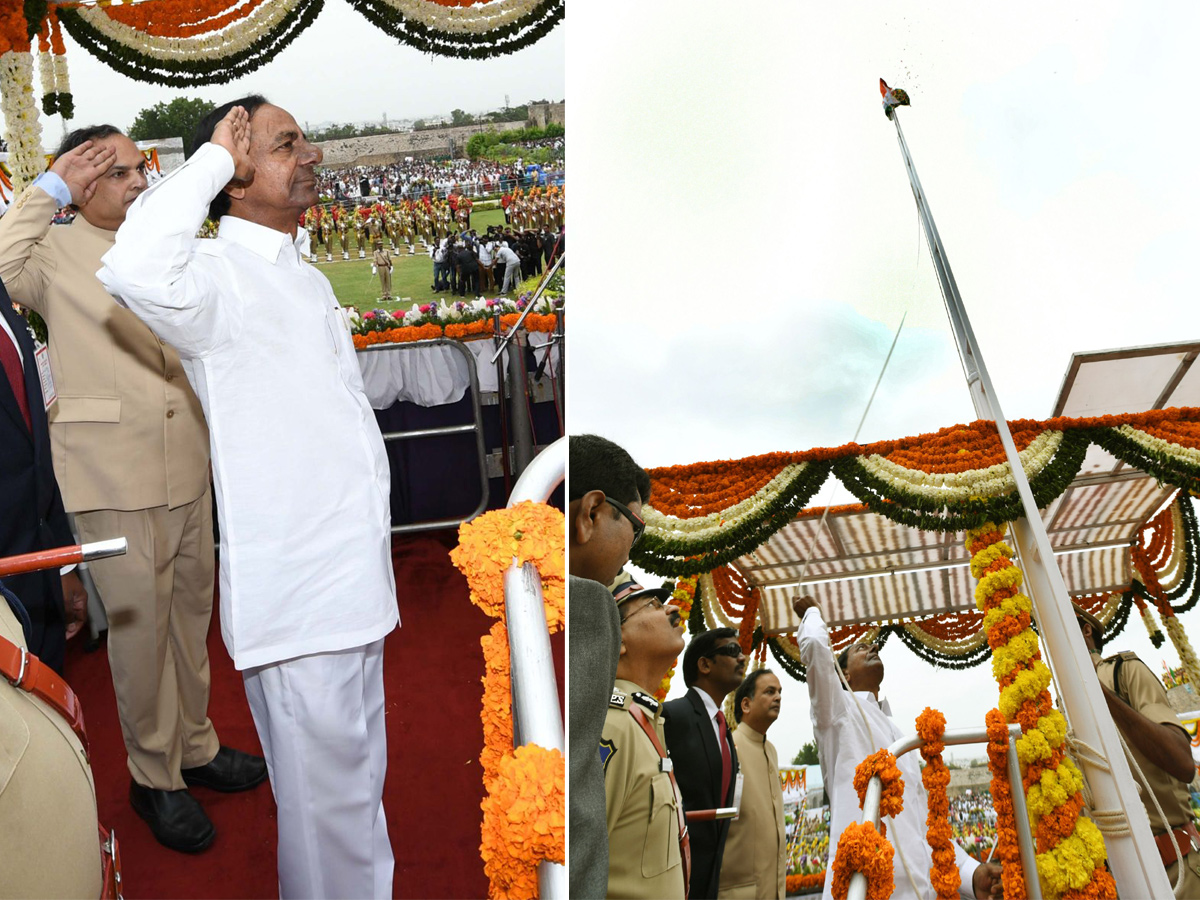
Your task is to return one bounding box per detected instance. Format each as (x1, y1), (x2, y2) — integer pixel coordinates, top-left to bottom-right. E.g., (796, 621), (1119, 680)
(664, 688), (738, 900)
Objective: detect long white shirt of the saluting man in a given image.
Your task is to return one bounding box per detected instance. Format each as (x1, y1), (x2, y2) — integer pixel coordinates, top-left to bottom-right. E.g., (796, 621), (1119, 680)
(97, 144), (400, 668)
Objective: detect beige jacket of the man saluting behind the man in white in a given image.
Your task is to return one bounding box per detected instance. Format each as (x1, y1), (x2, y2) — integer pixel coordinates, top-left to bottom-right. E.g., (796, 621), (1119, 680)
(0, 187), (209, 512)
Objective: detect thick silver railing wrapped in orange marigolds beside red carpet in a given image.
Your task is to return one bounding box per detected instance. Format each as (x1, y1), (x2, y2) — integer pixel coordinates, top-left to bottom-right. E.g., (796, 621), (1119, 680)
(504, 437), (568, 900)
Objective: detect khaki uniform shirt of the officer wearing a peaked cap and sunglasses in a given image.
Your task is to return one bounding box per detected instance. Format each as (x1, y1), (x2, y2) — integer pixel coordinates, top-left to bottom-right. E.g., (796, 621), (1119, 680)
(609, 678), (685, 900)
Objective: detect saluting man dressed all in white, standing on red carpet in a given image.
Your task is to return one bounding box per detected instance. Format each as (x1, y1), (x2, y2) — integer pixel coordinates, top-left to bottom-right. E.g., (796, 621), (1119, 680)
(98, 97), (398, 898)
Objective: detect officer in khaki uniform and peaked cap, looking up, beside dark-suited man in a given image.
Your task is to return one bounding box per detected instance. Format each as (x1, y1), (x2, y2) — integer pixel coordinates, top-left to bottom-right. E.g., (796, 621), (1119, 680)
(600, 572), (688, 900)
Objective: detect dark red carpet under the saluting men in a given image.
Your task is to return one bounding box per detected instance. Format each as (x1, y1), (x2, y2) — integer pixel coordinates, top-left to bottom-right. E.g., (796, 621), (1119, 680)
(59, 532), (563, 899)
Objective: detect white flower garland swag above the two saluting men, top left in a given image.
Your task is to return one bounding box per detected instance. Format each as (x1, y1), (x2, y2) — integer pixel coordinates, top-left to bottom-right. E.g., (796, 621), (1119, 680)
(76, 0), (299, 62)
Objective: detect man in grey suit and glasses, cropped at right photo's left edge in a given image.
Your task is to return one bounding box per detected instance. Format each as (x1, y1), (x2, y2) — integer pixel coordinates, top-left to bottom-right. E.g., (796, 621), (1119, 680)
(566, 434), (656, 900)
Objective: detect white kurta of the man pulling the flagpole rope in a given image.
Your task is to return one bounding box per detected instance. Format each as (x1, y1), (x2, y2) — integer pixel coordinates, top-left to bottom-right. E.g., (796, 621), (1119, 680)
(797, 610), (979, 900)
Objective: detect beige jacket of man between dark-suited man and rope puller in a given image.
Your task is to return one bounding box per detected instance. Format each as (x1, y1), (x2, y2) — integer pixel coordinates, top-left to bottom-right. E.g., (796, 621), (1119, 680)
(718, 722), (787, 900)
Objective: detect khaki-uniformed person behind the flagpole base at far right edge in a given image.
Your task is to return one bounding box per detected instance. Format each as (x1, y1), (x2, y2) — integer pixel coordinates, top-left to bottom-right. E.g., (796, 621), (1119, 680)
(1073, 604), (1200, 900)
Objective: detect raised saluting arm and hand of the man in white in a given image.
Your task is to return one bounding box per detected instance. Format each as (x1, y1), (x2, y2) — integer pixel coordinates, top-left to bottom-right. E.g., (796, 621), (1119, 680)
(96, 107), (253, 358)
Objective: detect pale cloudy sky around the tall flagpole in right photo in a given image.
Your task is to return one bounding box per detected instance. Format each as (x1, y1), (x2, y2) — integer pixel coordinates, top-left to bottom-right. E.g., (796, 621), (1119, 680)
(566, 1), (1200, 761)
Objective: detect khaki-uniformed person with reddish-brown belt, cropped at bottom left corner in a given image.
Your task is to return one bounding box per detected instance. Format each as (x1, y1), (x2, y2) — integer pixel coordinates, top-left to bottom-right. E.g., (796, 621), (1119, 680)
(0, 580), (102, 898)
